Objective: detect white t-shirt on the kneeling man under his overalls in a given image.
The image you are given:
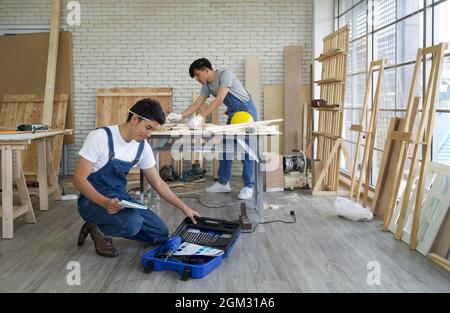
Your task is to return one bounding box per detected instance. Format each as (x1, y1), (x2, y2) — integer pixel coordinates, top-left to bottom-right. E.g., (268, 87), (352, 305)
(78, 125), (156, 173)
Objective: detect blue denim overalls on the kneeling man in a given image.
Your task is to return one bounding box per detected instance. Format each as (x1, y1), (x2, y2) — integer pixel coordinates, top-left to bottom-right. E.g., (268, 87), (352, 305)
(78, 127), (169, 244)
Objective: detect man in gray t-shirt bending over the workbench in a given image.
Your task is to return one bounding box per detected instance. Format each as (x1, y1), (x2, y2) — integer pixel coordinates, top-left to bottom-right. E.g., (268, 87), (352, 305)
(167, 58), (257, 200)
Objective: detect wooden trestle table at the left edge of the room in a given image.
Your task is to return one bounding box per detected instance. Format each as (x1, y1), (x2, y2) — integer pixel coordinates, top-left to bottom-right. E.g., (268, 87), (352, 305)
(0, 130), (72, 239)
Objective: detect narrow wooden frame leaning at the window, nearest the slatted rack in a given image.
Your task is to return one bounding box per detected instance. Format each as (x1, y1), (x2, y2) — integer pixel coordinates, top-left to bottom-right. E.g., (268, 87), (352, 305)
(350, 59), (387, 207)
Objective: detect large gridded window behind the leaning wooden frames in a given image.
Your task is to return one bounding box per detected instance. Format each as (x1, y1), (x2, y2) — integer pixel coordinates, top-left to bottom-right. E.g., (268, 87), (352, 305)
(335, 0), (450, 185)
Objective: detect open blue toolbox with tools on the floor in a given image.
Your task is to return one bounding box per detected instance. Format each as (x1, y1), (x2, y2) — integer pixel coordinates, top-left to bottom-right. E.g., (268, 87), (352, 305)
(142, 217), (241, 281)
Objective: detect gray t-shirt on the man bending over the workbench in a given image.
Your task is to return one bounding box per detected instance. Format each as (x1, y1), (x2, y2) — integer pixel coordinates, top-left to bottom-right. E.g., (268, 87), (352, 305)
(201, 70), (250, 102)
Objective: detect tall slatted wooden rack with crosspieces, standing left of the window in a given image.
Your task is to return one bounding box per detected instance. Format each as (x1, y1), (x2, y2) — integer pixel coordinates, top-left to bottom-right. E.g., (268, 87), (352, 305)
(306, 25), (351, 196)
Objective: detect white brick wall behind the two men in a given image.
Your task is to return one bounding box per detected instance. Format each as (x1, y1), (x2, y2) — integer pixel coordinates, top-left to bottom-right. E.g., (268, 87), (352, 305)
(0, 0), (313, 173)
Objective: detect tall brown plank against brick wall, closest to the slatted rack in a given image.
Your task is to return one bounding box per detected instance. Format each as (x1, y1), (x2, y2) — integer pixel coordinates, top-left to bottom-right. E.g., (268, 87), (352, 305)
(284, 46), (304, 154)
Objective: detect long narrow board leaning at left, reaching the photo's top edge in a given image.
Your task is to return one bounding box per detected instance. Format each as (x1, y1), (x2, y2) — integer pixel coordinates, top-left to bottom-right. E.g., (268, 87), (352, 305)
(42, 0), (61, 126)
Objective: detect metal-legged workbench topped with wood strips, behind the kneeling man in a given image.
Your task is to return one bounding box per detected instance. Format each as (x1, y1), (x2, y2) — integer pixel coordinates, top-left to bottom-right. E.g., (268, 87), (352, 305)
(141, 124), (281, 222)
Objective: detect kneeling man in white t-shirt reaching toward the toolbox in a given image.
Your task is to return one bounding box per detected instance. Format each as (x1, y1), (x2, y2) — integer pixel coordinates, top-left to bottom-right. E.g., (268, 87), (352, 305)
(73, 99), (200, 257)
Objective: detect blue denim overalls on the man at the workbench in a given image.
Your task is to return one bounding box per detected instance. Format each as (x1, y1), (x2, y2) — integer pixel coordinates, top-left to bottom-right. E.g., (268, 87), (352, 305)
(218, 92), (257, 188)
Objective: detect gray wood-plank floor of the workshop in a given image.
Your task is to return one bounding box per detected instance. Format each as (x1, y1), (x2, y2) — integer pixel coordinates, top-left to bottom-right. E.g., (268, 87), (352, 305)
(0, 179), (450, 293)
